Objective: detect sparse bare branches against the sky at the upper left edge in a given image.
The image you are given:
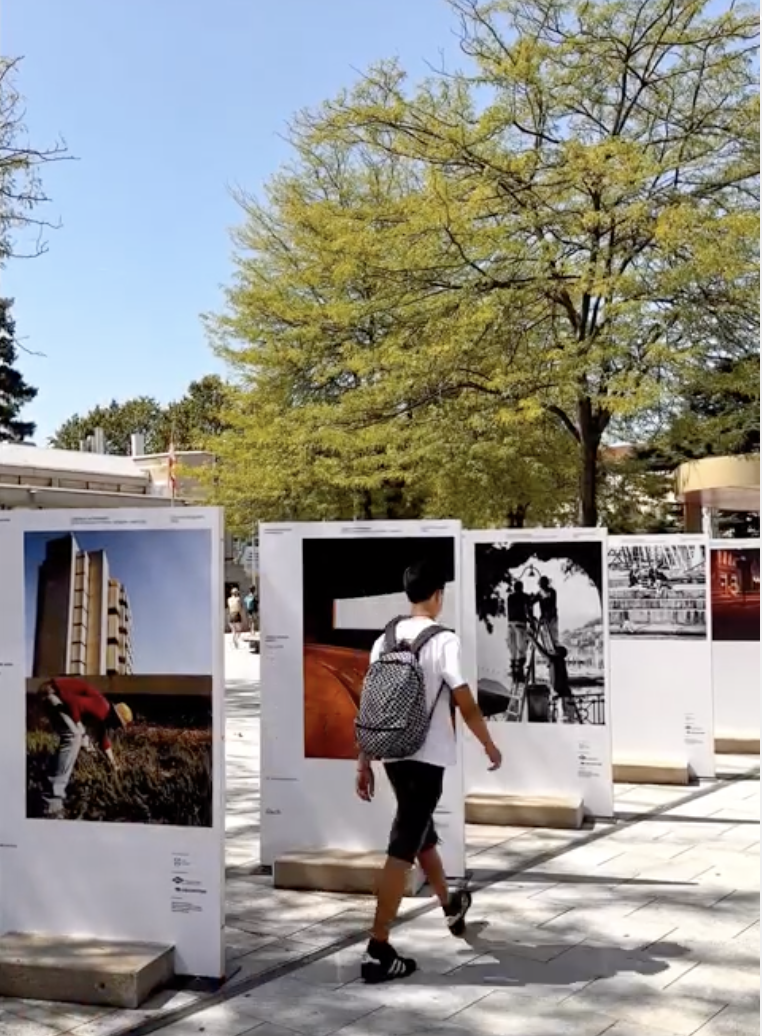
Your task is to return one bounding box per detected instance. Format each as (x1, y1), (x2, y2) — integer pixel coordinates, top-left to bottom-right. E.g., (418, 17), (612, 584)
(0, 57), (70, 264)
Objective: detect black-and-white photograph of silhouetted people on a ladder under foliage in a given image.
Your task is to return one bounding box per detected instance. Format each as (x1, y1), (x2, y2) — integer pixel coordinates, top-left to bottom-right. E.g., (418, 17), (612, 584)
(474, 540), (606, 726)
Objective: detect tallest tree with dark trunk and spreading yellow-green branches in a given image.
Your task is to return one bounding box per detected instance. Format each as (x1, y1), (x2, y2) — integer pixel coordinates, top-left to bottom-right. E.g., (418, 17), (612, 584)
(283, 0), (759, 524)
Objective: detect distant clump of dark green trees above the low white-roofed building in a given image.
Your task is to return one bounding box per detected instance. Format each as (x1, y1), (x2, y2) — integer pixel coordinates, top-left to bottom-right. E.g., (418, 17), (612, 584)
(50, 374), (227, 455)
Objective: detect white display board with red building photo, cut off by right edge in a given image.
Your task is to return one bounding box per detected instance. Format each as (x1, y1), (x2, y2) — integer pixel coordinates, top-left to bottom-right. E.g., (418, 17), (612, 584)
(710, 540), (760, 739)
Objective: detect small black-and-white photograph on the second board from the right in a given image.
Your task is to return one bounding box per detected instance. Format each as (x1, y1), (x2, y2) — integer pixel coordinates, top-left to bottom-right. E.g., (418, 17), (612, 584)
(609, 543), (706, 640)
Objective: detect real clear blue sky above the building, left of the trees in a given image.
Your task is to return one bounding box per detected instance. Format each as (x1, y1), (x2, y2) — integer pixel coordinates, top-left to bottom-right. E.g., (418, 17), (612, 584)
(2, 0), (460, 444)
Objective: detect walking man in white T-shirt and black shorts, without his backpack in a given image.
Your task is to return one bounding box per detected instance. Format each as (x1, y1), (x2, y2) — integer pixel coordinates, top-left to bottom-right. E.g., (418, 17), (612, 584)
(356, 563), (502, 982)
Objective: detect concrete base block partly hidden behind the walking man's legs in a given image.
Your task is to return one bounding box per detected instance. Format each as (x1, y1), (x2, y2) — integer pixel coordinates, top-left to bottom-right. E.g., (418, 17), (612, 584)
(272, 848), (423, 896)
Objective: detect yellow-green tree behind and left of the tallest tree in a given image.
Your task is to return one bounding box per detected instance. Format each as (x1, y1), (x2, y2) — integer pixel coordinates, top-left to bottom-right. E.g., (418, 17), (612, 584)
(207, 130), (569, 528)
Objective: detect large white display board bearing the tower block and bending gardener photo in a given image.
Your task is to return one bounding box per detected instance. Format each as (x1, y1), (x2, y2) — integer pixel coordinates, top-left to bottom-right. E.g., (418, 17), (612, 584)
(0, 508), (225, 978)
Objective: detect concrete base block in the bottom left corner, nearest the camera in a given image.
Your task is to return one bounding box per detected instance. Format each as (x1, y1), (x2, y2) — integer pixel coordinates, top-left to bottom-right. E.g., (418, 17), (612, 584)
(0, 932), (175, 1009)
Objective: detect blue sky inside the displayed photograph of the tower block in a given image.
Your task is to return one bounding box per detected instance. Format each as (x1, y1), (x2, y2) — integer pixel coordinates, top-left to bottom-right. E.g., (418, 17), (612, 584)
(24, 529), (211, 677)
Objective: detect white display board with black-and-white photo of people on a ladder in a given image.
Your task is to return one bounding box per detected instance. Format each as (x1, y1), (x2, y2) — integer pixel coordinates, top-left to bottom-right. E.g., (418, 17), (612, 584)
(463, 528), (614, 816)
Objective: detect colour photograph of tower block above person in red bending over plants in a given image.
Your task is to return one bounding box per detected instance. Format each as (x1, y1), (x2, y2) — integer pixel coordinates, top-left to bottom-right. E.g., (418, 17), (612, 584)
(24, 528), (214, 827)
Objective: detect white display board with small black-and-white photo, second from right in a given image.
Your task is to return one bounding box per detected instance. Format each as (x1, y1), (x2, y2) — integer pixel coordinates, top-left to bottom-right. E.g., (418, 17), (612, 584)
(609, 536), (714, 777)
